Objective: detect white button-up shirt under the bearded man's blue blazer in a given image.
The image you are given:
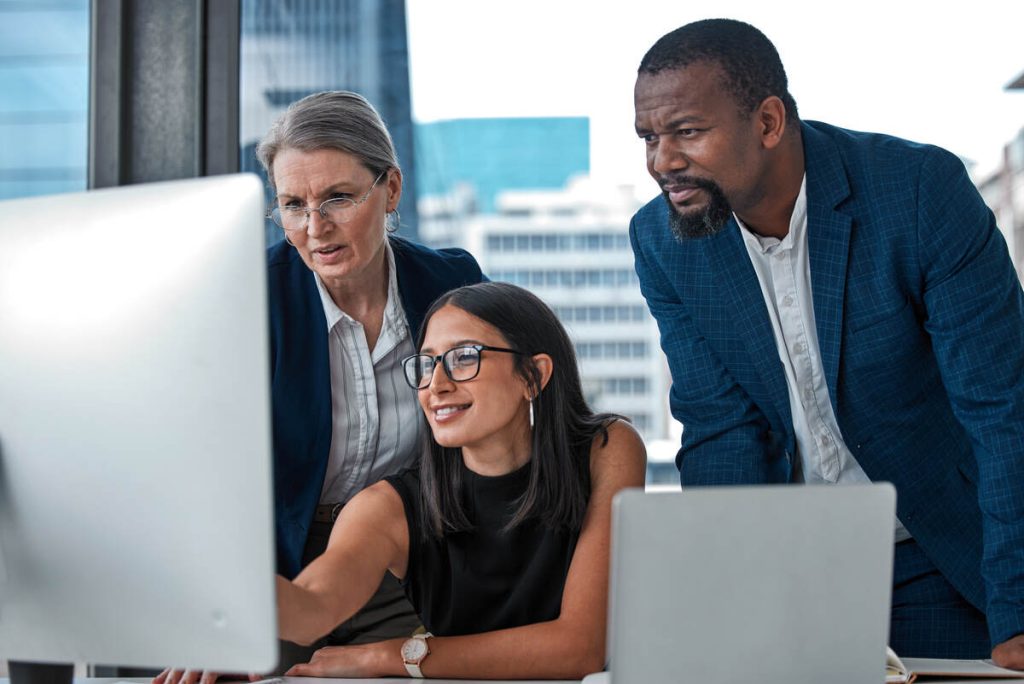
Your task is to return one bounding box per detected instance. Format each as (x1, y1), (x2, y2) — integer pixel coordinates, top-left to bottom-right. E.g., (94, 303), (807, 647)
(736, 176), (910, 542)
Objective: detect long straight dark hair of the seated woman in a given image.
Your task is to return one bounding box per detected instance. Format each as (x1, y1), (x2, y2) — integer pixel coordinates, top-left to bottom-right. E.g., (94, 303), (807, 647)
(417, 283), (620, 537)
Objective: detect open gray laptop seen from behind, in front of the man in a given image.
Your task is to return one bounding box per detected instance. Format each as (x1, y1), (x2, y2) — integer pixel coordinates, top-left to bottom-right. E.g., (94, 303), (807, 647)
(587, 483), (896, 684)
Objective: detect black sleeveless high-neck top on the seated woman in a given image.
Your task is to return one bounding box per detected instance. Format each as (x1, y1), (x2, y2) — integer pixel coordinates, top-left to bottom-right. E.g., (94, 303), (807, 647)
(386, 463), (580, 636)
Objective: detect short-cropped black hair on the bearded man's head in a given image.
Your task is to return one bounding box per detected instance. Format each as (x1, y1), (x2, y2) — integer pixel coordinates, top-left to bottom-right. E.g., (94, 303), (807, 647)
(637, 19), (800, 122)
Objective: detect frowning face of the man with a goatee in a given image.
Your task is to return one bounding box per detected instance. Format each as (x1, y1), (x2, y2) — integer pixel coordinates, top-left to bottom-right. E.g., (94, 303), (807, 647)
(634, 61), (766, 238)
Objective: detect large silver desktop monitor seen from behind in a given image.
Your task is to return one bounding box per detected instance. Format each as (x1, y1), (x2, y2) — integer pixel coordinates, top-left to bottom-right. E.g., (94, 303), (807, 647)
(0, 174), (278, 672)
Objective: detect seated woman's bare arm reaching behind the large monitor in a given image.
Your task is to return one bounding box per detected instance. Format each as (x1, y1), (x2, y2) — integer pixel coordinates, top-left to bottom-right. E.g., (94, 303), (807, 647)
(278, 482), (409, 645)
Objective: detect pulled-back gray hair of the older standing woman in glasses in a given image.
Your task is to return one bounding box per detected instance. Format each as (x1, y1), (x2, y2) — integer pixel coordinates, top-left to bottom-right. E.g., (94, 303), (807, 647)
(256, 90), (400, 187)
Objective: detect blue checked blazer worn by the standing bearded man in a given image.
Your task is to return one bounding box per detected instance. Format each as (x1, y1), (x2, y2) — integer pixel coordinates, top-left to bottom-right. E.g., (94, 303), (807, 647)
(630, 122), (1024, 643)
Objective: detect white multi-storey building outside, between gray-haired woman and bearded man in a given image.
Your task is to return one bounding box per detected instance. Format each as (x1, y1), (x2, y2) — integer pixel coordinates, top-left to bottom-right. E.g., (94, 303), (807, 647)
(420, 178), (679, 443)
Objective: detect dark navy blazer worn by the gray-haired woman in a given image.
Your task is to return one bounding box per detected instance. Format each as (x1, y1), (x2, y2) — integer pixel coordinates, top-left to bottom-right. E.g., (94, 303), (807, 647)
(267, 236), (483, 578)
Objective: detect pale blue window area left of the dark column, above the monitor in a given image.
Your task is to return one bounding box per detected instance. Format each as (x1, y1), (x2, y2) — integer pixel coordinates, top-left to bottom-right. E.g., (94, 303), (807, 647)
(0, 0), (89, 200)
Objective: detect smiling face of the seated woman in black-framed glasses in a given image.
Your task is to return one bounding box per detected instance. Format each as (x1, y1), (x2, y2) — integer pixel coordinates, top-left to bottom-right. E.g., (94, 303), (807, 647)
(419, 305), (530, 474)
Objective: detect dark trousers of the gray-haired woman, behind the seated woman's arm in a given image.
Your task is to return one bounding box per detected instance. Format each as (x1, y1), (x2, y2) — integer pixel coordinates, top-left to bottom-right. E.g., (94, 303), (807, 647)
(276, 522), (421, 674)
